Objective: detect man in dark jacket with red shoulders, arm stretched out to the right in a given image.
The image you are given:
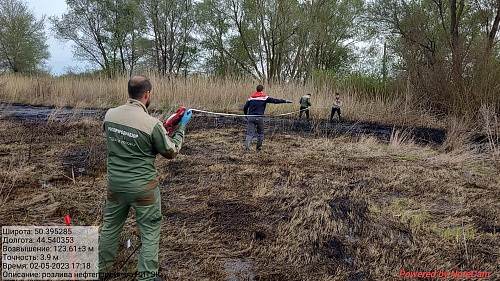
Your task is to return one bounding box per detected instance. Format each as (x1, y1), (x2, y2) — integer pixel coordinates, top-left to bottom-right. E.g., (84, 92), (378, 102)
(243, 85), (292, 152)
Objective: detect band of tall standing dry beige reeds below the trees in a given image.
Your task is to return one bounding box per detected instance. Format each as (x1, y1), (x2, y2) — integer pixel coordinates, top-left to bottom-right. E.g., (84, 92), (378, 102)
(0, 73), (444, 127)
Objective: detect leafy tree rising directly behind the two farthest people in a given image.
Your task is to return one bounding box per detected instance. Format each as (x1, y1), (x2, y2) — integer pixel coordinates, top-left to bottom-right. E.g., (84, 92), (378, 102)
(290, 0), (366, 79)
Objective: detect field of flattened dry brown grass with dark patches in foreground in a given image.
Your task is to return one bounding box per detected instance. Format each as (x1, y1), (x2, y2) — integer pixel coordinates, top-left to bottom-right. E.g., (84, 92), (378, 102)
(0, 110), (500, 281)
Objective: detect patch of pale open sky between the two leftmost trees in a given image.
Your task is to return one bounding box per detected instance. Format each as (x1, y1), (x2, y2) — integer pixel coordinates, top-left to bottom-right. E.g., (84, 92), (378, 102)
(24, 0), (85, 76)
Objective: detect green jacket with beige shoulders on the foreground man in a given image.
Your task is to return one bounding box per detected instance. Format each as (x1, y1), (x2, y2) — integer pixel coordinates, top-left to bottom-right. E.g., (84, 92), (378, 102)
(104, 99), (186, 193)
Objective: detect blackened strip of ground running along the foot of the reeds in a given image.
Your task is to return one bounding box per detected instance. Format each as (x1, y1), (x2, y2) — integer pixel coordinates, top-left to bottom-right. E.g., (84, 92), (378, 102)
(0, 103), (446, 145)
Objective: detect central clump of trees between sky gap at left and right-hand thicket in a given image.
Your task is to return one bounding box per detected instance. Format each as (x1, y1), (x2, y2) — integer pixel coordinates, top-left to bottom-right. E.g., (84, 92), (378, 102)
(51, 0), (366, 82)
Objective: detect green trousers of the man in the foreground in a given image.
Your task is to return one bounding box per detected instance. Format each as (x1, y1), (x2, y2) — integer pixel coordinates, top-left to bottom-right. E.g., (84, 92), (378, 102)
(99, 187), (162, 280)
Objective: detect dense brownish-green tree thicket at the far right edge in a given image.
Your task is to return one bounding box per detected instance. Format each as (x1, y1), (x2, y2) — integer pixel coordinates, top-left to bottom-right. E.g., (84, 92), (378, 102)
(371, 0), (500, 114)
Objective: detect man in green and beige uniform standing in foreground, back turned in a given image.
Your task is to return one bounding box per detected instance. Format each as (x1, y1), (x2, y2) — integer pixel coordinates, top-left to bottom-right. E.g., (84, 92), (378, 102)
(99, 76), (192, 280)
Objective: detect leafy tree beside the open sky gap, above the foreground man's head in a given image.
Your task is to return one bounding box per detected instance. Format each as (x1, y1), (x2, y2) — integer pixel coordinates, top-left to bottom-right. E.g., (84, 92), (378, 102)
(51, 0), (145, 76)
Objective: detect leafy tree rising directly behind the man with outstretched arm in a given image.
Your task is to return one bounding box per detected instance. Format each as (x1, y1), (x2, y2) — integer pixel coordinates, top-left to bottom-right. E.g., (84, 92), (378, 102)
(226, 0), (298, 82)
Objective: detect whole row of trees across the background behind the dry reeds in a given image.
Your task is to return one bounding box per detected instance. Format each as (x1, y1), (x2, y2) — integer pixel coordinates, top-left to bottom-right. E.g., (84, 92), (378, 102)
(0, 0), (500, 114)
